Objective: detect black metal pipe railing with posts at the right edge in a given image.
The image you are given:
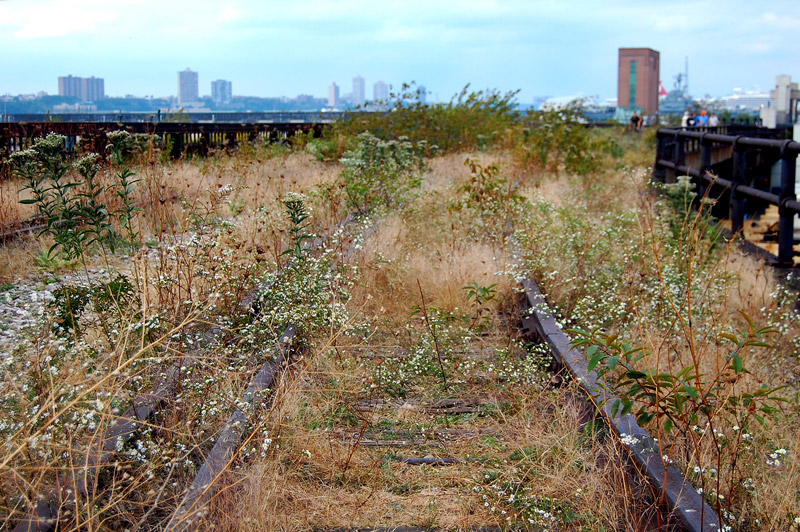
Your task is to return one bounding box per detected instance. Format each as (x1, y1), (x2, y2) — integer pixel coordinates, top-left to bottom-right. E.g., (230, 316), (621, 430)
(654, 128), (800, 265)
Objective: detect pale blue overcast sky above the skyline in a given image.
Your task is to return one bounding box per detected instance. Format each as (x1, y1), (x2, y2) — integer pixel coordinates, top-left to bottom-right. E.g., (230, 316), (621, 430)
(0, 0), (800, 102)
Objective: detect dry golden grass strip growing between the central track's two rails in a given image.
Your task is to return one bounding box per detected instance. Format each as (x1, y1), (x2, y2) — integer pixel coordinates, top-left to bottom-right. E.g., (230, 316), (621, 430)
(200, 150), (664, 530)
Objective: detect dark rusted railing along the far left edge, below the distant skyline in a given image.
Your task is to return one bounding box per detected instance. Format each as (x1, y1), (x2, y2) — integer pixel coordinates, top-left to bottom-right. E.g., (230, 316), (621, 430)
(0, 122), (325, 161)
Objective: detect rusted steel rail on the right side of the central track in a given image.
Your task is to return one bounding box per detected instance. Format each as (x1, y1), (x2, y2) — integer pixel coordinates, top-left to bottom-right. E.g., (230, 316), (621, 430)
(522, 280), (721, 532)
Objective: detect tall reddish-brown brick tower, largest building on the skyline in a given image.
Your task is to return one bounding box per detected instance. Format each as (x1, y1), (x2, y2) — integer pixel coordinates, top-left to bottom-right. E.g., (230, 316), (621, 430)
(617, 48), (660, 115)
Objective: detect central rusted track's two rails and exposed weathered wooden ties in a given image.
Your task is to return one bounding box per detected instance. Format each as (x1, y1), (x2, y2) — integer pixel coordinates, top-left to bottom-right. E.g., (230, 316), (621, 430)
(153, 281), (720, 532)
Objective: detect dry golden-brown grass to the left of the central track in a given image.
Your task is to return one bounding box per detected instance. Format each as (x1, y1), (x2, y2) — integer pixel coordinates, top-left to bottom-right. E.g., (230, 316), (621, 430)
(0, 145), (334, 529)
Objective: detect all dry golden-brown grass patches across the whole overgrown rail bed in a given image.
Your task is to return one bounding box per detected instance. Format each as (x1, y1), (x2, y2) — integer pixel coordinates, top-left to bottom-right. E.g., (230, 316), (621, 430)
(0, 130), (800, 530)
